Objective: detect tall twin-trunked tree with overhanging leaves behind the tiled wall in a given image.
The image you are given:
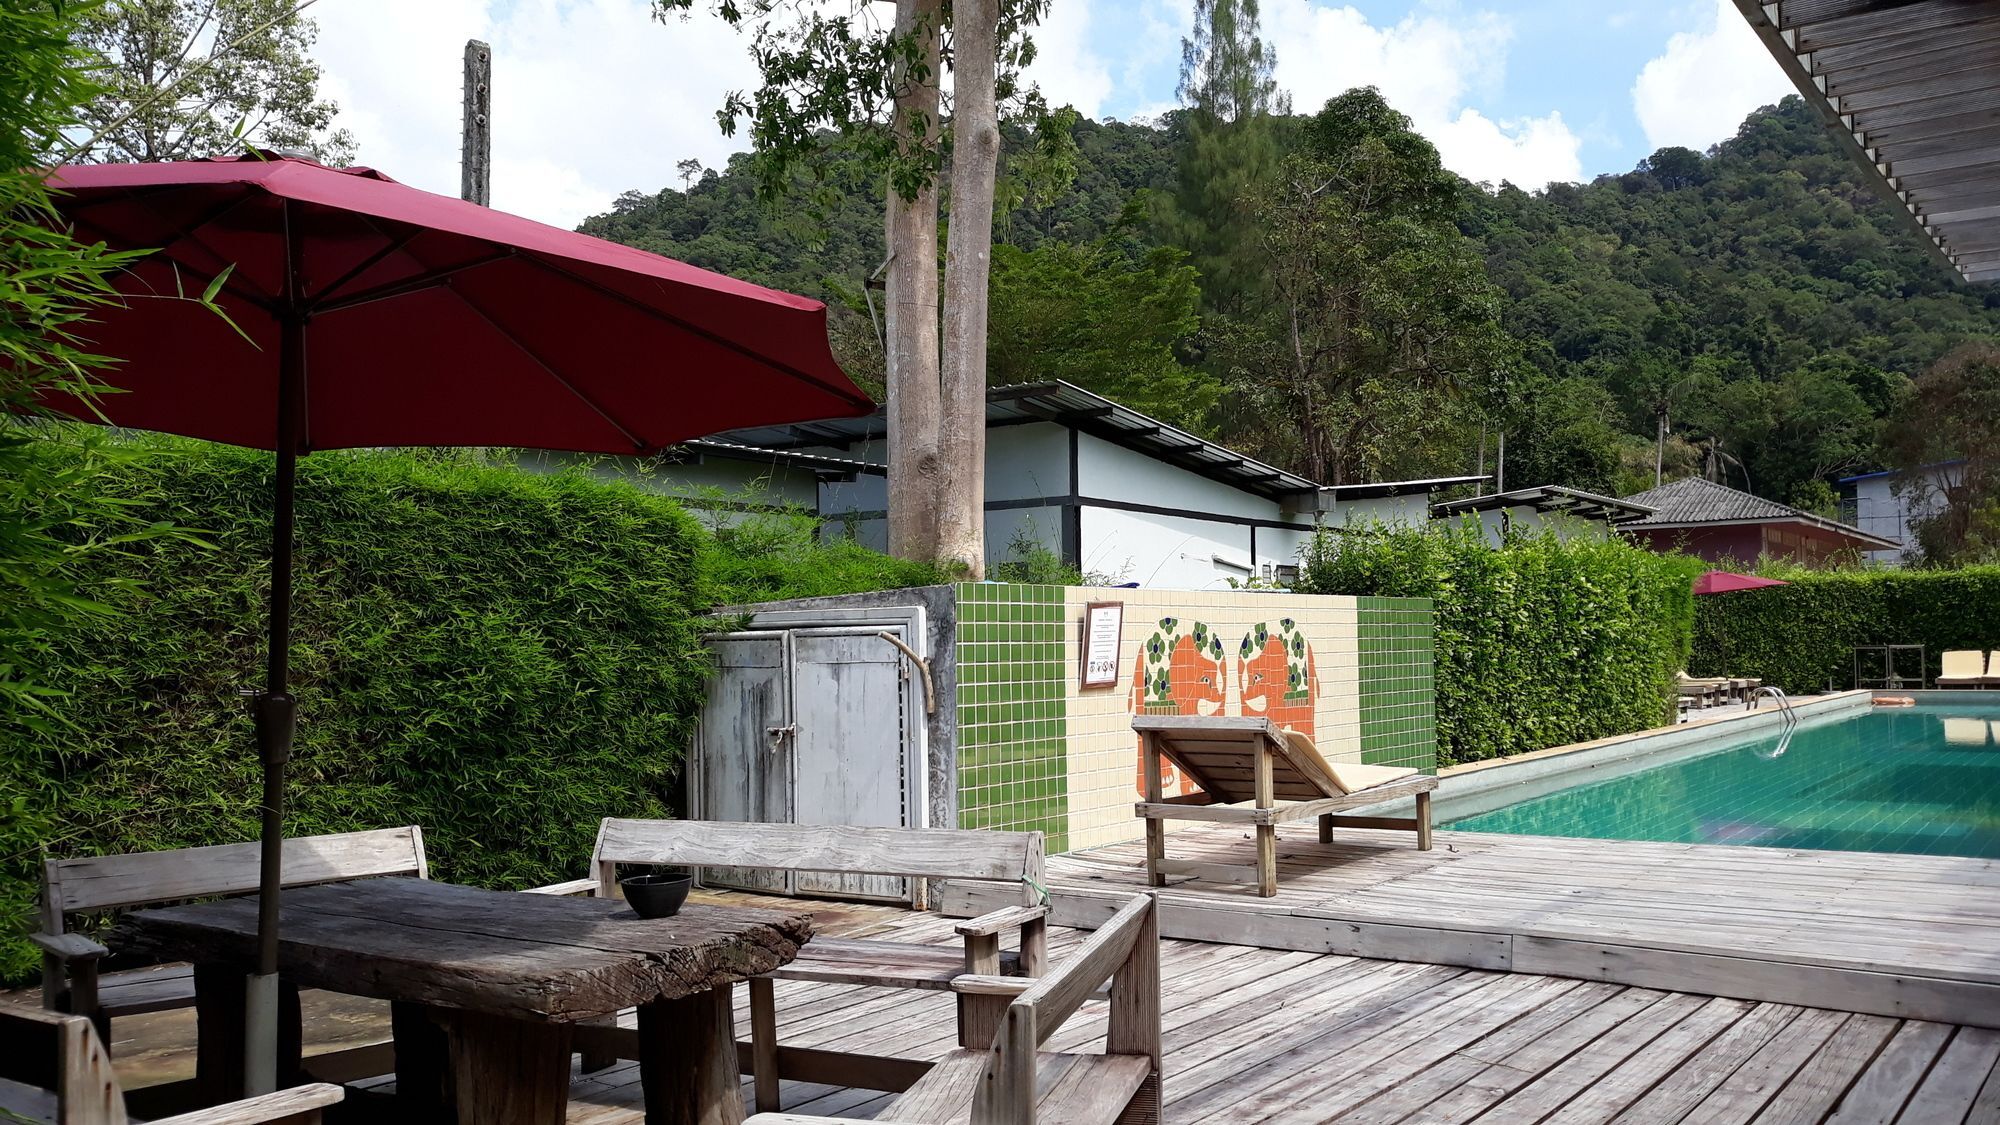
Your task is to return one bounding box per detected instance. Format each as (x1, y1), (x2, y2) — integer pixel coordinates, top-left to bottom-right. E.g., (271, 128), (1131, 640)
(654, 0), (1066, 577)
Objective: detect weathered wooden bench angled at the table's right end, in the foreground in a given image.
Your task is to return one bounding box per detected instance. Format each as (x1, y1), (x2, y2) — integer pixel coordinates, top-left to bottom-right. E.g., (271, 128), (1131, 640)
(744, 895), (1160, 1125)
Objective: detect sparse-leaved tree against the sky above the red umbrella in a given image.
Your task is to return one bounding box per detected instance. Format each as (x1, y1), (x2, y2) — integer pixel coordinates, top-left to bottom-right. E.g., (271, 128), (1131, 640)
(76, 0), (354, 164)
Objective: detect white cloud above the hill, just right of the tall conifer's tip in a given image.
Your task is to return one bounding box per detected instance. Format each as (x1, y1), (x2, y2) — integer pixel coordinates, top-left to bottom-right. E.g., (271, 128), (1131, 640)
(1264, 0), (1582, 188)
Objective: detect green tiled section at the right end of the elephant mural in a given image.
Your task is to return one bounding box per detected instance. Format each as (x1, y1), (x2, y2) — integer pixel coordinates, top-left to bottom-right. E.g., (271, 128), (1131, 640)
(1356, 599), (1438, 773)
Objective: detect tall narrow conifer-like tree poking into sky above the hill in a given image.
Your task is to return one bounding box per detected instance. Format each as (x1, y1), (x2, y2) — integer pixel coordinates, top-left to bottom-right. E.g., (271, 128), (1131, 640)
(1162, 0), (1292, 310)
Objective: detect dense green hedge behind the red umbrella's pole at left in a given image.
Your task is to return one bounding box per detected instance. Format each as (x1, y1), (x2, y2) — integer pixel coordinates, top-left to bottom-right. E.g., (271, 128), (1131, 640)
(0, 442), (710, 979)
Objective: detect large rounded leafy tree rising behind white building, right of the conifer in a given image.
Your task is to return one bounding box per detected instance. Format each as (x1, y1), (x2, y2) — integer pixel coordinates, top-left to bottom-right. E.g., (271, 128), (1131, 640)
(1246, 88), (1520, 484)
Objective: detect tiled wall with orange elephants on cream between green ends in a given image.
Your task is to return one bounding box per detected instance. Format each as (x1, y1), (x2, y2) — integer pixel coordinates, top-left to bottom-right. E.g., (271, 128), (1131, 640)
(956, 583), (1436, 851)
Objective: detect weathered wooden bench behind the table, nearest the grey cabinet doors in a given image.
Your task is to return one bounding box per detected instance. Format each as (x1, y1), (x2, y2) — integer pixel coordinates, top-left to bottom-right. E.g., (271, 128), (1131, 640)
(536, 819), (1048, 1109)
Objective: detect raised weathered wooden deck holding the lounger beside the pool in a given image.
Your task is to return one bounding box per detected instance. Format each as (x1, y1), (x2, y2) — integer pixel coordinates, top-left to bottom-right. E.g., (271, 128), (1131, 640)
(942, 825), (2000, 1027)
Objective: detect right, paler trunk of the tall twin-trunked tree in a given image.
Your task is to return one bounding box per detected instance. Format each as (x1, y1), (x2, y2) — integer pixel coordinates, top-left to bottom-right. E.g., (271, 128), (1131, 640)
(938, 0), (1000, 579)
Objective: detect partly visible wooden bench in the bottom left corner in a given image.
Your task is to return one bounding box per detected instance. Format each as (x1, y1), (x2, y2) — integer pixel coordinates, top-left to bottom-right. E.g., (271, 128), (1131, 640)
(0, 1005), (342, 1125)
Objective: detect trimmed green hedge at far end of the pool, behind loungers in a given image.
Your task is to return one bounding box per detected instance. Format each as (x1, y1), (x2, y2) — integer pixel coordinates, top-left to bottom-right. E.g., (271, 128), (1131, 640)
(1690, 567), (2000, 695)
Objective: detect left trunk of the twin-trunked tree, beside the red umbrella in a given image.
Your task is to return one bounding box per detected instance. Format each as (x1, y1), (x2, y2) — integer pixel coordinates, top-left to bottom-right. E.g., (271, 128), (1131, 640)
(884, 0), (948, 563)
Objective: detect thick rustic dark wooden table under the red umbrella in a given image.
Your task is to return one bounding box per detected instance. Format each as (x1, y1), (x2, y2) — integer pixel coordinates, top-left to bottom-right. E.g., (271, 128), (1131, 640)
(128, 879), (812, 1125)
